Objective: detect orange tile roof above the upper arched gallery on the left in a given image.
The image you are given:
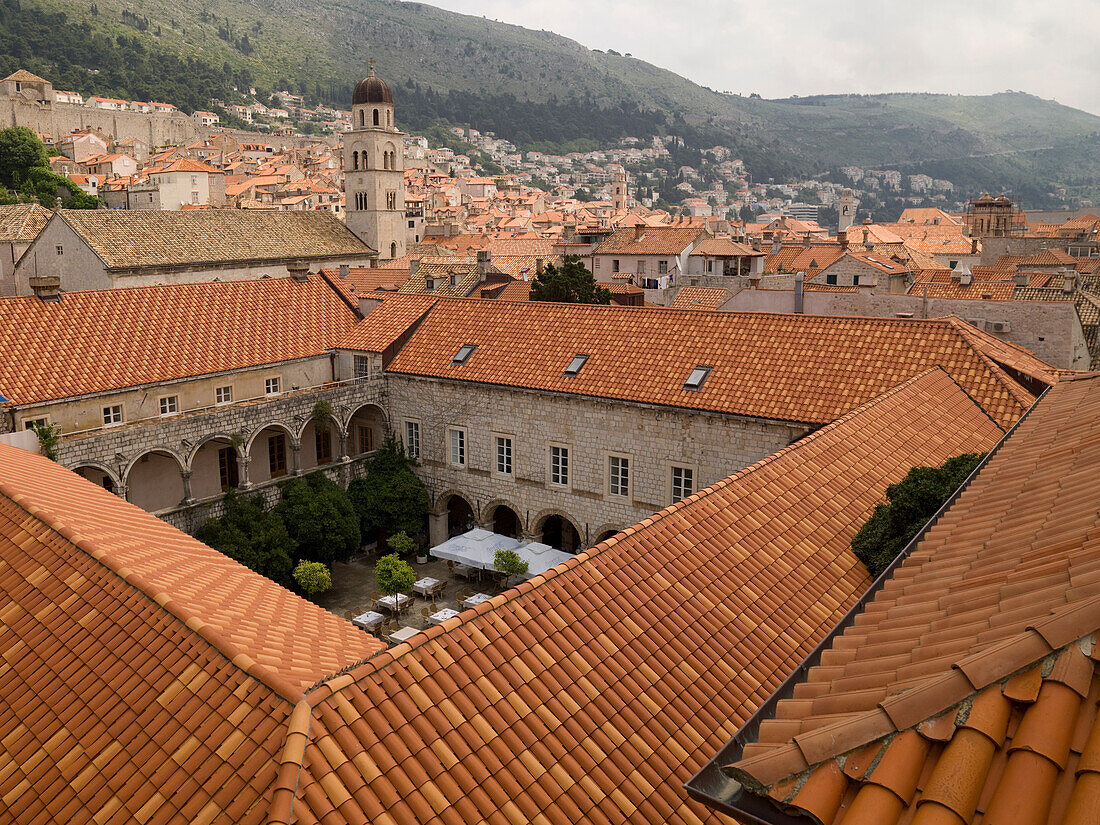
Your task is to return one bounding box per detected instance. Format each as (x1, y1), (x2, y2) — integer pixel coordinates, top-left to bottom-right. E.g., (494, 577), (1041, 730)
(0, 275), (359, 404)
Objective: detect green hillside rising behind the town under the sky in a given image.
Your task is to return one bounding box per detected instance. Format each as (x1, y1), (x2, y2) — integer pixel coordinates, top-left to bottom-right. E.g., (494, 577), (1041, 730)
(8, 0), (1100, 206)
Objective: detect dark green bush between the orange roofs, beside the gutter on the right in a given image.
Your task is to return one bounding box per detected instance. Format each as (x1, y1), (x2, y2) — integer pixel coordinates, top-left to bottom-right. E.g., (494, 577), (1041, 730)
(851, 453), (985, 578)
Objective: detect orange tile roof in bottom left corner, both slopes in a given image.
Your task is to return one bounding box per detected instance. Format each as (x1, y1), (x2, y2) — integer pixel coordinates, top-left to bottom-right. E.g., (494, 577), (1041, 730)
(0, 444), (382, 825)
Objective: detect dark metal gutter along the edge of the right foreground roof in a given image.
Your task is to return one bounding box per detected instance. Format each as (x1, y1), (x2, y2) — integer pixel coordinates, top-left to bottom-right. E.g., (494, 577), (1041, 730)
(684, 387), (1051, 825)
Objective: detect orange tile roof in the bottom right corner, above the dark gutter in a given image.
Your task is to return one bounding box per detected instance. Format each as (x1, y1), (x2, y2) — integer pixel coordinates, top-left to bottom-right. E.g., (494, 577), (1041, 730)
(704, 374), (1100, 825)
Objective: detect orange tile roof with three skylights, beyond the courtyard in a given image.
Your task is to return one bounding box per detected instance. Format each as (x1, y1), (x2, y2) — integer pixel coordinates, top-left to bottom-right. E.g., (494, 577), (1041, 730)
(389, 300), (1056, 425)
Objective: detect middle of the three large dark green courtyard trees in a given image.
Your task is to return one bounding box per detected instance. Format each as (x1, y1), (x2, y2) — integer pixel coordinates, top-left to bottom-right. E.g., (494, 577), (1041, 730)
(275, 471), (363, 564)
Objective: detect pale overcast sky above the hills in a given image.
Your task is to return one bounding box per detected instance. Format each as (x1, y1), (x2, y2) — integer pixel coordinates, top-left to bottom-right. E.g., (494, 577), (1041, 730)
(418, 0), (1100, 114)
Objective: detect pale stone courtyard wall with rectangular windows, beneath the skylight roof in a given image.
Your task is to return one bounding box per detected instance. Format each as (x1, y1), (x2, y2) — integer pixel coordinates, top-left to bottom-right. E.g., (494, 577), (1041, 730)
(387, 375), (810, 546)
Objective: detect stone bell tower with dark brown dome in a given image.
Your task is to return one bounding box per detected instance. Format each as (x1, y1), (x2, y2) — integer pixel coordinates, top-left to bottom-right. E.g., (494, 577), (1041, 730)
(344, 65), (406, 261)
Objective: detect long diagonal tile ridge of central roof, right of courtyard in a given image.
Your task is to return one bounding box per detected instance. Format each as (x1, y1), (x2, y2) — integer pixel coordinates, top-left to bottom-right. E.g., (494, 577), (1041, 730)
(306, 365), (963, 704)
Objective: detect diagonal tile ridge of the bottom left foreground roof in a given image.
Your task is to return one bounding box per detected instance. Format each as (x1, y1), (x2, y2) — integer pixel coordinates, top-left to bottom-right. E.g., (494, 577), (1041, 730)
(0, 488), (303, 704)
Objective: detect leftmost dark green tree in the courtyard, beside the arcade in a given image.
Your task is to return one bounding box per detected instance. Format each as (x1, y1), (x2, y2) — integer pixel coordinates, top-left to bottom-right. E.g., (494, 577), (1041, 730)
(195, 490), (297, 585)
